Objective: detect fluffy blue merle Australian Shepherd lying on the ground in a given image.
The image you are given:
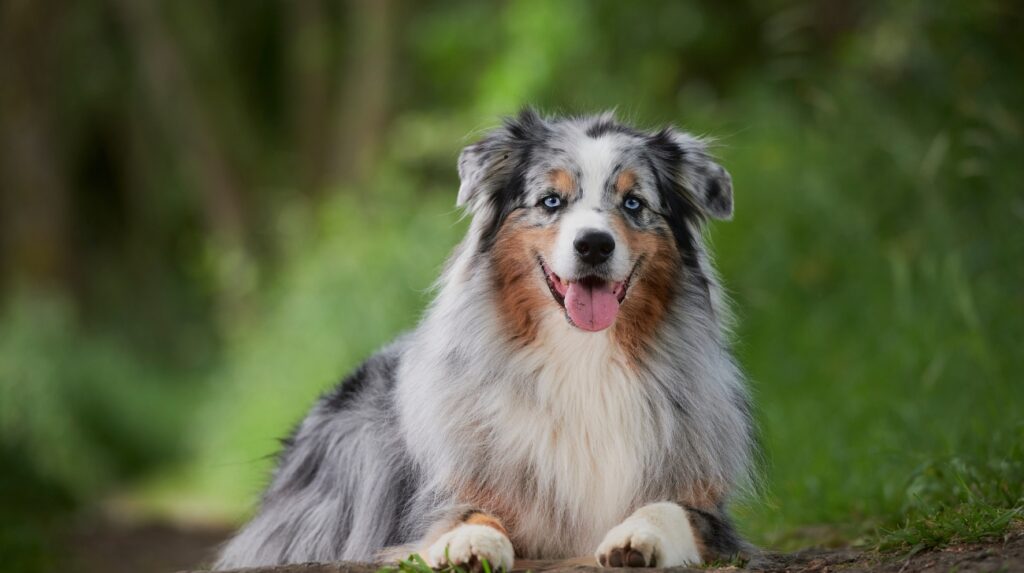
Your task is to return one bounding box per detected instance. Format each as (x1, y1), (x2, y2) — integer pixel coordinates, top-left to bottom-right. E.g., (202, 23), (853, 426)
(216, 108), (754, 570)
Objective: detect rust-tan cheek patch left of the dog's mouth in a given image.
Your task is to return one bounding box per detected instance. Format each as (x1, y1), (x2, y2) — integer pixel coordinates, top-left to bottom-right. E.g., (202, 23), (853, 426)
(494, 214), (555, 346)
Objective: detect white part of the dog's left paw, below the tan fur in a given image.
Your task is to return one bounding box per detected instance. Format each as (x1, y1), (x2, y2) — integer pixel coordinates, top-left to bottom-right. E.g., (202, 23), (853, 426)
(424, 524), (515, 571)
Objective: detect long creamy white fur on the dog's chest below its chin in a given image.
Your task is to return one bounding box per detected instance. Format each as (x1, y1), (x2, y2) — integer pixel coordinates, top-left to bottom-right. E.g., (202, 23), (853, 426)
(490, 317), (657, 555)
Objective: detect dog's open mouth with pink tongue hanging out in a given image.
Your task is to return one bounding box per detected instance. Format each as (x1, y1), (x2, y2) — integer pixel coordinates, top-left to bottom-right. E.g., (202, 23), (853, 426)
(538, 257), (636, 333)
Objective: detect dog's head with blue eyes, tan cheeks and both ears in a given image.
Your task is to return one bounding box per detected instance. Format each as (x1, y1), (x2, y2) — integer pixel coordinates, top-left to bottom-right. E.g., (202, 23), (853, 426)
(458, 109), (732, 347)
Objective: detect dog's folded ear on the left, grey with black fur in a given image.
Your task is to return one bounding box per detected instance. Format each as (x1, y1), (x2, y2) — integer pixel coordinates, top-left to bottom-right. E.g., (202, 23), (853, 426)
(456, 107), (548, 213)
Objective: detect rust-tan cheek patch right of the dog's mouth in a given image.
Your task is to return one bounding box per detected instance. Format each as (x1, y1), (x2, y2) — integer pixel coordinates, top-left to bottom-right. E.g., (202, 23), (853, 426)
(612, 217), (682, 363)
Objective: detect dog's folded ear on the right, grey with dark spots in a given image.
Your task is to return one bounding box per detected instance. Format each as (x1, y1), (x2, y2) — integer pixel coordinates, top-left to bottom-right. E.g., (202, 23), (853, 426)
(648, 128), (732, 220)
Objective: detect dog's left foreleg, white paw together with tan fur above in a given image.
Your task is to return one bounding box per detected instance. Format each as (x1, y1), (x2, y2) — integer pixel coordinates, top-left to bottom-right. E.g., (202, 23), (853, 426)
(421, 511), (515, 571)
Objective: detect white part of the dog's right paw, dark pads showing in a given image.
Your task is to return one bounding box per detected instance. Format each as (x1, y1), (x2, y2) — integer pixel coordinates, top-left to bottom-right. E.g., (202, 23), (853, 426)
(594, 502), (700, 567)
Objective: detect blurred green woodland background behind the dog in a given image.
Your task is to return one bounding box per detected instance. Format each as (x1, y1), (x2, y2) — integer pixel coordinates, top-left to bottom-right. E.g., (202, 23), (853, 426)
(0, 0), (1024, 571)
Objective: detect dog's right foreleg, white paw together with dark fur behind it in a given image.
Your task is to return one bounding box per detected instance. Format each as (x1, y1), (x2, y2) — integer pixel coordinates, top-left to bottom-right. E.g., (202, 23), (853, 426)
(595, 501), (740, 567)
